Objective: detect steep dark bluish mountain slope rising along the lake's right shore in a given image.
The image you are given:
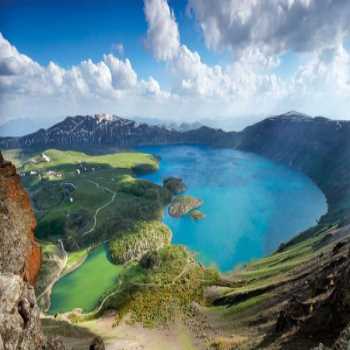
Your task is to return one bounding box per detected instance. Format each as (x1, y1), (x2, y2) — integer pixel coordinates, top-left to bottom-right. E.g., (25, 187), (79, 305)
(235, 113), (350, 223)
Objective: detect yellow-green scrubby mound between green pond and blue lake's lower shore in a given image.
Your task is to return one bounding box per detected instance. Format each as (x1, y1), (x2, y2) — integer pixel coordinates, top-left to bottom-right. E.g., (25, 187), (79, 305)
(105, 245), (218, 327)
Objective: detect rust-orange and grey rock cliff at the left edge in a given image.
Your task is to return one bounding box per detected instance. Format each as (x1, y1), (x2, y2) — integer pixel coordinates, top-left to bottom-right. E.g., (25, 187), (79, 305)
(0, 153), (64, 350)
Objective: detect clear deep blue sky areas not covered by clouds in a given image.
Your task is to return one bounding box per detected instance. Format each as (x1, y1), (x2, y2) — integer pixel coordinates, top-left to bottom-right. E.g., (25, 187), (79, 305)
(0, 0), (217, 84)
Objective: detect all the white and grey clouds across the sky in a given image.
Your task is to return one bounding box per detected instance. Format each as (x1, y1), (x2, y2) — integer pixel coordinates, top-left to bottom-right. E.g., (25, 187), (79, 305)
(0, 0), (350, 126)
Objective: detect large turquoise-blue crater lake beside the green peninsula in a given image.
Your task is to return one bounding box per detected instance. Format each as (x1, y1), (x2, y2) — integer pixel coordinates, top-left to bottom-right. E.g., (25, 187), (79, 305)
(138, 145), (327, 271)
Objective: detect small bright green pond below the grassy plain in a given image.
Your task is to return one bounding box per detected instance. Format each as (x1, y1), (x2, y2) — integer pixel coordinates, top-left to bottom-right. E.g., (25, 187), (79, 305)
(49, 246), (123, 314)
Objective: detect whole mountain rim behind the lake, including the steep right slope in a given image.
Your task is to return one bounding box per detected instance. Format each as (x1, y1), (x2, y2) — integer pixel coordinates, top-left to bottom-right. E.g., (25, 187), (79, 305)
(0, 112), (350, 224)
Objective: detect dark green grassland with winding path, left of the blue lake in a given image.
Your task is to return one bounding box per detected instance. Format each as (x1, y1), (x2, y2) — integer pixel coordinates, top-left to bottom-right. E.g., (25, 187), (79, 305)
(17, 149), (170, 252)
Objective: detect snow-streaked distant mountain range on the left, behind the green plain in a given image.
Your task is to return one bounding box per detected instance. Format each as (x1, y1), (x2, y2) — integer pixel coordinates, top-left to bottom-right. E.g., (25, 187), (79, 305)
(0, 114), (228, 149)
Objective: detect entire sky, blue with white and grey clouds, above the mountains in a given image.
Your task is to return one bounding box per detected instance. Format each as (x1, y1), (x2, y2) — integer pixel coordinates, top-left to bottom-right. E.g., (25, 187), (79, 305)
(0, 0), (350, 122)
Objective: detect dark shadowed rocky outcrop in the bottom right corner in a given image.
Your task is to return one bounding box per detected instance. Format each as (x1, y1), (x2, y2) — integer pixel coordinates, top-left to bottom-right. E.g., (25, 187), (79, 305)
(275, 240), (350, 350)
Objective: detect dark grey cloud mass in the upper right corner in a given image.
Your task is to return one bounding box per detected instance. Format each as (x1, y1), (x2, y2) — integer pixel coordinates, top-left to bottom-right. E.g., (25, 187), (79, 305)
(188, 0), (350, 54)
